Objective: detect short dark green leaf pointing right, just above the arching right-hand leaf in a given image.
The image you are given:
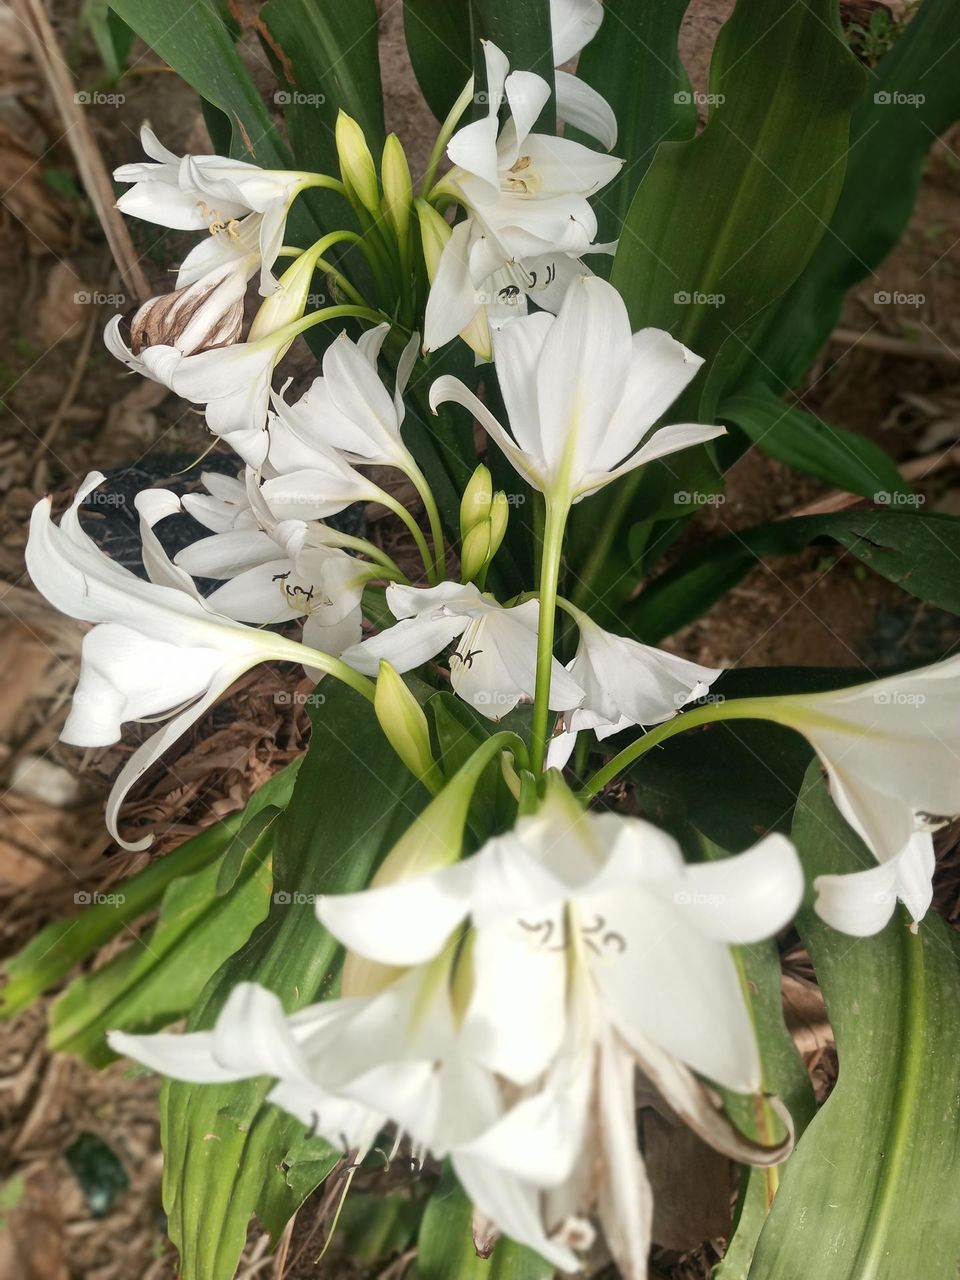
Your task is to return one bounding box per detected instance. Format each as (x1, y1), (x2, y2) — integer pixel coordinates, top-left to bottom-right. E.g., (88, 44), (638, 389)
(717, 387), (911, 502)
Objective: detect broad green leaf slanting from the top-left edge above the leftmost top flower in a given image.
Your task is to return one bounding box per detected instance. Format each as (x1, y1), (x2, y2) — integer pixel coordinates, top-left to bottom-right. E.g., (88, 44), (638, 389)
(110, 0), (291, 169)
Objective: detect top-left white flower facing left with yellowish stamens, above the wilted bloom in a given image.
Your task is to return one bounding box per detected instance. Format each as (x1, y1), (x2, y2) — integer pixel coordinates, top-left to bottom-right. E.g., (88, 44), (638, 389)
(114, 124), (315, 296)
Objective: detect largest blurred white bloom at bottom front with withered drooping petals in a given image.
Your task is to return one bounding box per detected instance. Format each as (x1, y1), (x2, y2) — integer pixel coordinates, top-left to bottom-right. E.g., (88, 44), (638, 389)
(317, 788), (803, 1277)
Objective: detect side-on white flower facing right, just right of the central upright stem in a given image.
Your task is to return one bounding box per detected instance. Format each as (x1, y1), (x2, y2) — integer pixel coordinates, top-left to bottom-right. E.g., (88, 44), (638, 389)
(549, 602), (722, 768)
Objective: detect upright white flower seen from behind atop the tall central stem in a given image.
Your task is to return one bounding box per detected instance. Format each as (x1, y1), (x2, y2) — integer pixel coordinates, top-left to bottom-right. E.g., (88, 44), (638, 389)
(430, 276), (724, 506)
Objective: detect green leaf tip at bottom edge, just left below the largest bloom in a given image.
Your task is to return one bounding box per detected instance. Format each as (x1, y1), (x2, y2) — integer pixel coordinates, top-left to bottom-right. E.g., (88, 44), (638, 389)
(416, 1165), (553, 1280)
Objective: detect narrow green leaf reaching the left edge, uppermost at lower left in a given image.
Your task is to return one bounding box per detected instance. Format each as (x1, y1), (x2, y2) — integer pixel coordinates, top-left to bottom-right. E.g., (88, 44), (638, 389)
(0, 759), (301, 1018)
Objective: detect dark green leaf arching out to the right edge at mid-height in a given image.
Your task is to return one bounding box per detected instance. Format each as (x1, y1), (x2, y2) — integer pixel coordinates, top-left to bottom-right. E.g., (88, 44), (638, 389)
(622, 495), (960, 644)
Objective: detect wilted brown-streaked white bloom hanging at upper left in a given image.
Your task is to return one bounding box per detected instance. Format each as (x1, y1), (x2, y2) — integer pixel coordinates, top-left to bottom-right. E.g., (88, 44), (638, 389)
(128, 263), (247, 356)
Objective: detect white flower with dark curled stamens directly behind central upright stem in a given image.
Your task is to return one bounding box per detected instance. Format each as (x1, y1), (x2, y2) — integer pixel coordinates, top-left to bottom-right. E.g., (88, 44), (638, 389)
(343, 582), (584, 719)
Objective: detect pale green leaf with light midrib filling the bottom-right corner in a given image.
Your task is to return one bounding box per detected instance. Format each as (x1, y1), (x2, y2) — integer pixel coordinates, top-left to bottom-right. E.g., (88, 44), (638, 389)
(750, 765), (960, 1280)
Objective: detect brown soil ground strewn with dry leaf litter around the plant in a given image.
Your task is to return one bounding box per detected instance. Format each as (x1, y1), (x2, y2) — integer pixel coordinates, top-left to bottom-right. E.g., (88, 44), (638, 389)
(0, 0), (960, 1280)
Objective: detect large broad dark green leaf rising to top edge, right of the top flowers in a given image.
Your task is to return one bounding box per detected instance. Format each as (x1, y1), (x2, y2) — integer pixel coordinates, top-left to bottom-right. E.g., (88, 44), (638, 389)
(611, 0), (864, 421)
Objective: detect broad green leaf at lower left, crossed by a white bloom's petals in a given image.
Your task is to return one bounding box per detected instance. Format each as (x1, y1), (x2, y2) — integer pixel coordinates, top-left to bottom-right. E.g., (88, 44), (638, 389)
(161, 680), (426, 1280)
